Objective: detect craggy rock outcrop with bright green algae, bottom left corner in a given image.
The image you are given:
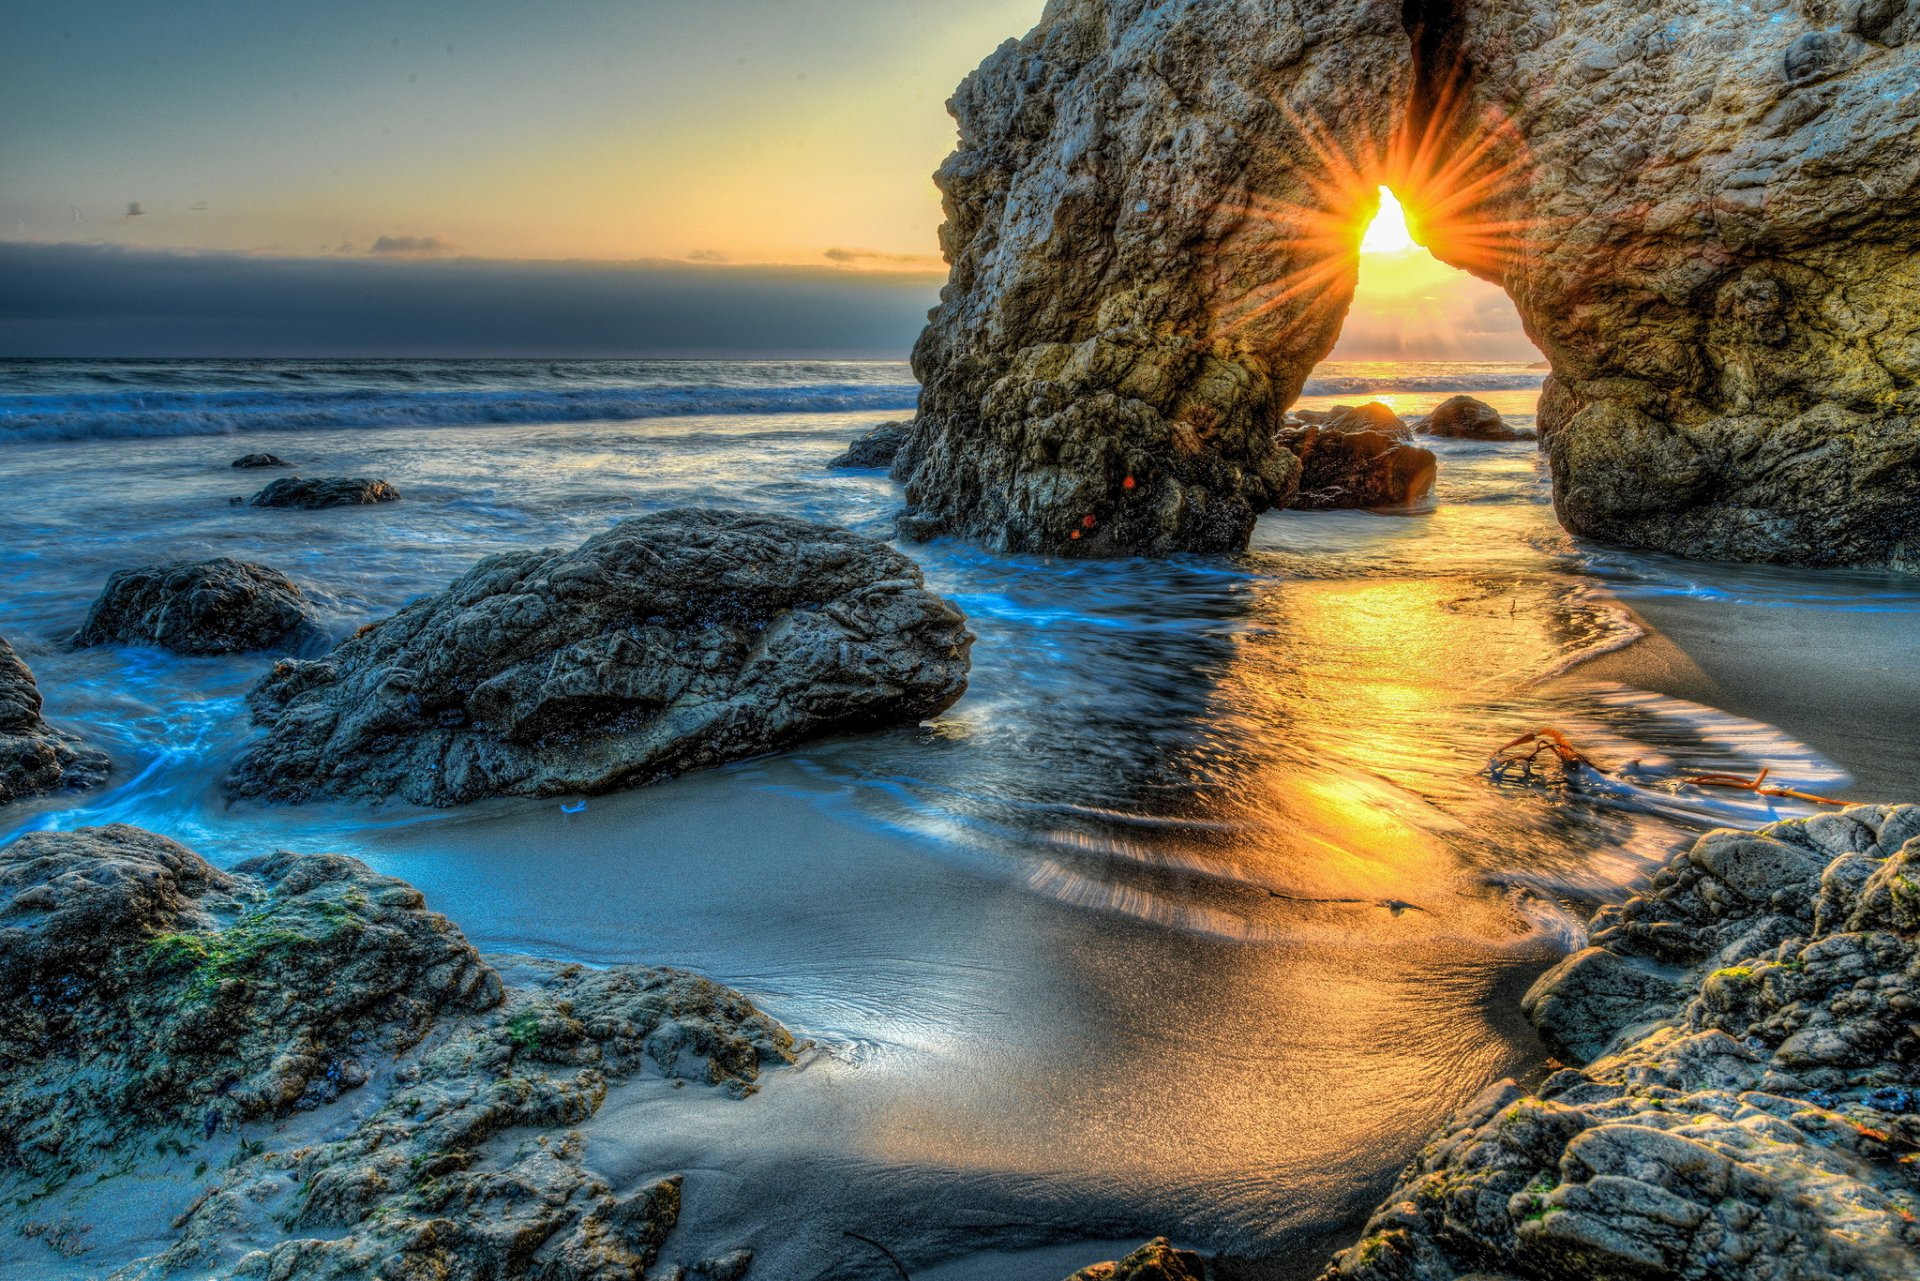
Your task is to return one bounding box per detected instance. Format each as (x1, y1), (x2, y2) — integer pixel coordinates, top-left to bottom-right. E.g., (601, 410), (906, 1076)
(0, 826), (793, 1281)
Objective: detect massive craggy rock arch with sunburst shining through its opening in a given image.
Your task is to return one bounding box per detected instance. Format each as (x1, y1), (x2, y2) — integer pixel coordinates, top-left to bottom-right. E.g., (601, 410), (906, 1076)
(895, 0), (1920, 567)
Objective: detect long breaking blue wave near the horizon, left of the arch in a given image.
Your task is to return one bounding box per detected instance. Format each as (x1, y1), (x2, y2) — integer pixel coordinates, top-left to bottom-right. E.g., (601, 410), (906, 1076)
(0, 382), (920, 440)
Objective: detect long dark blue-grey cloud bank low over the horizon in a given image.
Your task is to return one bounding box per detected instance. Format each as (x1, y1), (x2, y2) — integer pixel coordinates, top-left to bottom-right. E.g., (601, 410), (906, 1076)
(0, 242), (945, 359)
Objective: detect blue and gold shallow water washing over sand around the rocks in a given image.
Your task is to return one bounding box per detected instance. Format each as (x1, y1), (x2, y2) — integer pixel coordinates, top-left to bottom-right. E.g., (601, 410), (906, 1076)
(0, 363), (1920, 1277)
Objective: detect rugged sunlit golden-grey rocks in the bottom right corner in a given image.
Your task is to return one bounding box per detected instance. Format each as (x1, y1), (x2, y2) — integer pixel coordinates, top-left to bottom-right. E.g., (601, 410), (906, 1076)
(1327, 805), (1920, 1281)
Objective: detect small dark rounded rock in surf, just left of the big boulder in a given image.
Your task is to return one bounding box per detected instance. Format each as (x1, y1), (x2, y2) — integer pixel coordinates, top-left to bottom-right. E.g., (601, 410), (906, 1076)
(73, 557), (313, 653)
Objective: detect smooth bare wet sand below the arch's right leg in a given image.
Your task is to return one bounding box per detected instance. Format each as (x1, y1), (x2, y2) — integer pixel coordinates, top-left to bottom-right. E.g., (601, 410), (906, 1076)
(1569, 597), (1920, 801)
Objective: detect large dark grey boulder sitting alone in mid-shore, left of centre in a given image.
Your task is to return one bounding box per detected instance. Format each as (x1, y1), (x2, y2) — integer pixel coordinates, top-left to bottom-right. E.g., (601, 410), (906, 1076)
(228, 509), (973, 805)
